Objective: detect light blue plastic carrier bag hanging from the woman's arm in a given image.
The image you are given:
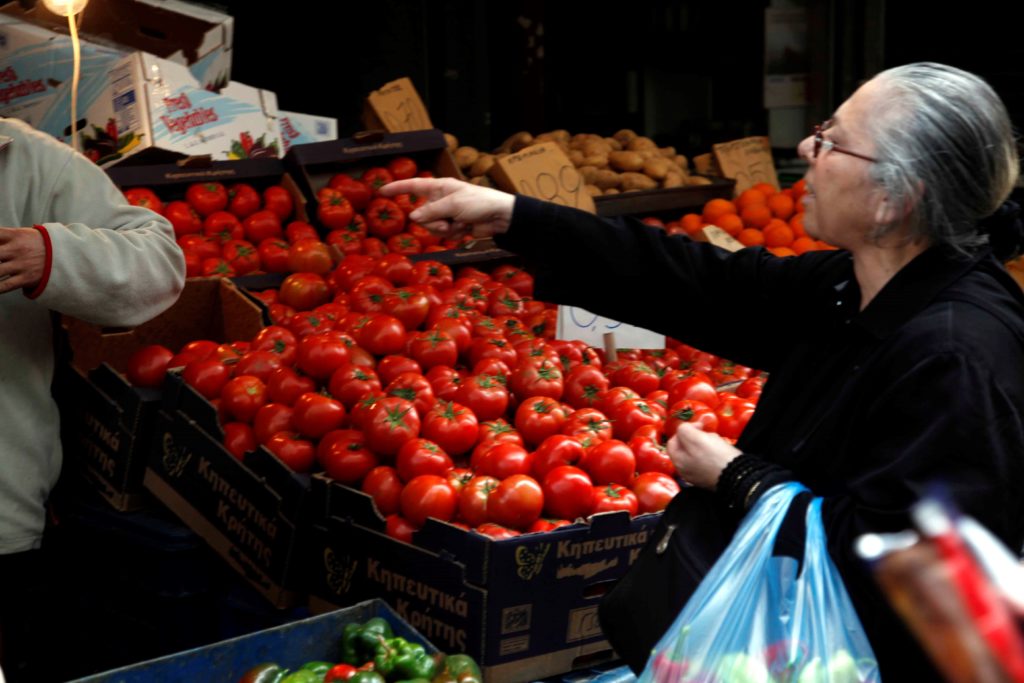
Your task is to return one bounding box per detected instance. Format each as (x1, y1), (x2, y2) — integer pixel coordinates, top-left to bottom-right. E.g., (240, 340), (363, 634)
(640, 483), (881, 683)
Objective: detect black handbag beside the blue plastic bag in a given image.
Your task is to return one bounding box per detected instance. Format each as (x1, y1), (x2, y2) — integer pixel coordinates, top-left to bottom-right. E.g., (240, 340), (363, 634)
(598, 488), (810, 675)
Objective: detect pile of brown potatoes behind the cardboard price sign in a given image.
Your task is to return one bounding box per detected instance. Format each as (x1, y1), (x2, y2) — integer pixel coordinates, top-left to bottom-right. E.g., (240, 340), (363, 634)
(445, 129), (711, 197)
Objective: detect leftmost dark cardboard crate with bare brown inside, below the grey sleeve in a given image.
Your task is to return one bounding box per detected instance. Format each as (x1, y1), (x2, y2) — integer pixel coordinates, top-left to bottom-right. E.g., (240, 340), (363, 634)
(57, 279), (265, 510)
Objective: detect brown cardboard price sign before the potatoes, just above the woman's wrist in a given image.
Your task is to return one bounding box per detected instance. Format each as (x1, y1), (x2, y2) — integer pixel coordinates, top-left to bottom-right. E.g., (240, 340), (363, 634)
(488, 142), (597, 213)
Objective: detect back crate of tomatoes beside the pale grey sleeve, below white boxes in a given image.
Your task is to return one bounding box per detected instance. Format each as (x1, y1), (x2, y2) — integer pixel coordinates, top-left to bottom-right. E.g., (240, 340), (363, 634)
(108, 159), (334, 278)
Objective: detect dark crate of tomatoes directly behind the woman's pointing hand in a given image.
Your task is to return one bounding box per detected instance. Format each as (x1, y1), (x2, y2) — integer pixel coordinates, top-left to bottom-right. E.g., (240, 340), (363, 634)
(285, 130), (462, 254)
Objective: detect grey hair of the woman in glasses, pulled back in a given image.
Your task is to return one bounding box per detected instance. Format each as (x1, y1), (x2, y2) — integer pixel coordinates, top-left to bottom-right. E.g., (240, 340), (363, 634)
(868, 62), (1020, 250)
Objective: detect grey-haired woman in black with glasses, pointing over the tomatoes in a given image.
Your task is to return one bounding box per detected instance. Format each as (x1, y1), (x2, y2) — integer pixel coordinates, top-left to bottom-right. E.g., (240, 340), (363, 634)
(384, 63), (1024, 680)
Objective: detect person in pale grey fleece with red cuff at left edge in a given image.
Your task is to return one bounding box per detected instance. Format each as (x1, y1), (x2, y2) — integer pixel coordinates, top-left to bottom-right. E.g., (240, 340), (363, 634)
(0, 119), (185, 683)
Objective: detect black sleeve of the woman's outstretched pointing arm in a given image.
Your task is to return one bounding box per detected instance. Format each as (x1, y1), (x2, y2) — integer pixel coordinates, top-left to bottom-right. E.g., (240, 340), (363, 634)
(495, 196), (847, 371)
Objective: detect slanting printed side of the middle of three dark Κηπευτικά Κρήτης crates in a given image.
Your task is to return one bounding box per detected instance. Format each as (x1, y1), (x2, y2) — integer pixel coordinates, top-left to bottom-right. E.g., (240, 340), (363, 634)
(143, 368), (309, 607)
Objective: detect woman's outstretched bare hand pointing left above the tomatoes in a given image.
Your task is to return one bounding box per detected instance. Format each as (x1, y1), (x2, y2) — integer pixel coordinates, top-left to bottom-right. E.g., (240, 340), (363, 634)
(379, 178), (515, 238)
